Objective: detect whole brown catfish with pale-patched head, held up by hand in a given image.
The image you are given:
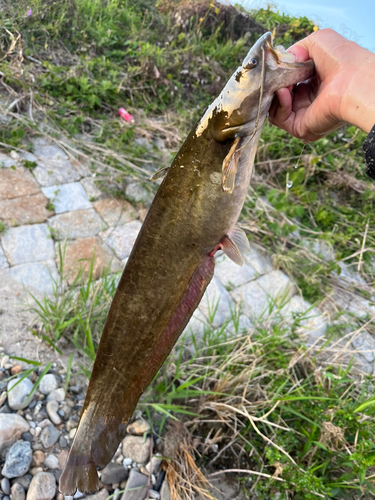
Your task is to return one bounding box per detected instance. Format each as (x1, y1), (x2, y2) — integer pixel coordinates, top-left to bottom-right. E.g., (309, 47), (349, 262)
(60, 33), (314, 495)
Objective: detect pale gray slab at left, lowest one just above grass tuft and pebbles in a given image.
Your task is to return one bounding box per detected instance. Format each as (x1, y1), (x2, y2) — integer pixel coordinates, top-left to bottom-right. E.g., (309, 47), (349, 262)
(7, 260), (58, 294)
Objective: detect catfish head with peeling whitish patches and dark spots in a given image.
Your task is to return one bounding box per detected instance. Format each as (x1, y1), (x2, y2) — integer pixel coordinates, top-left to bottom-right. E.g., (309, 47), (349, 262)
(207, 32), (314, 141)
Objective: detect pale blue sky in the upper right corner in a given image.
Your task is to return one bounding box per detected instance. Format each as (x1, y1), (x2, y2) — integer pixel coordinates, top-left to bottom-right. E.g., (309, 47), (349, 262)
(232, 0), (375, 52)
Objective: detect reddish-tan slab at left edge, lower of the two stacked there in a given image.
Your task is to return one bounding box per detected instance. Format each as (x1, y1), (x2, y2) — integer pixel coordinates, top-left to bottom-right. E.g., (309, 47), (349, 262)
(0, 193), (54, 226)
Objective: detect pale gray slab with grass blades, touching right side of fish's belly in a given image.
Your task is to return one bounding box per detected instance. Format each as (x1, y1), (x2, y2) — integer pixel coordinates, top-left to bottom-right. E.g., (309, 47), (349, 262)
(199, 277), (235, 328)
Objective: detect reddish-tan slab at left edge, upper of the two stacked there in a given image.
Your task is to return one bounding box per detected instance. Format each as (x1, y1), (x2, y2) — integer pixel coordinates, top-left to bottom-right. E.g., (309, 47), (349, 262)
(0, 167), (40, 200)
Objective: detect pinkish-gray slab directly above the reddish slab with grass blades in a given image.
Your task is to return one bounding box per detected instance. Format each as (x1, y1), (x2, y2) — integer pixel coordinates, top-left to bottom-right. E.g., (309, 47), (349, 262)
(48, 208), (107, 240)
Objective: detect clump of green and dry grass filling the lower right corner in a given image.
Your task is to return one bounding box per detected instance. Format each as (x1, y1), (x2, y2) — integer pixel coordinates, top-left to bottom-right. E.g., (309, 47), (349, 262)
(143, 311), (375, 499)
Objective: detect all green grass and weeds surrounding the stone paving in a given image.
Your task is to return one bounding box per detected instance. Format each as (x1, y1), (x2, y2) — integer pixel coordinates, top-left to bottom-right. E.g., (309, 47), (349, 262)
(0, 0), (375, 500)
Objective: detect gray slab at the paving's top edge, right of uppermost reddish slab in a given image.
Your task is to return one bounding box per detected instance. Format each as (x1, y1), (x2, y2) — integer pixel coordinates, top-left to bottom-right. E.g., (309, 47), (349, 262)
(33, 159), (81, 187)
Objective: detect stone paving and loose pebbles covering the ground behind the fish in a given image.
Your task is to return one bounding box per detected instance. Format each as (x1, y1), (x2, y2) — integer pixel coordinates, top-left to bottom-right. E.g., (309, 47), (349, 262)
(0, 139), (375, 500)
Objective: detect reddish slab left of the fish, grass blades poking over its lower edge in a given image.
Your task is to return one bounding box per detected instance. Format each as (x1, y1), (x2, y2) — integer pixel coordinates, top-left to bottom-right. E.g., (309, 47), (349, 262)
(56, 236), (122, 283)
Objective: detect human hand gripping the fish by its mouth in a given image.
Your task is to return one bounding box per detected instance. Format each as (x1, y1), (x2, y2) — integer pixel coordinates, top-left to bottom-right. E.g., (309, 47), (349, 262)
(269, 29), (375, 141)
